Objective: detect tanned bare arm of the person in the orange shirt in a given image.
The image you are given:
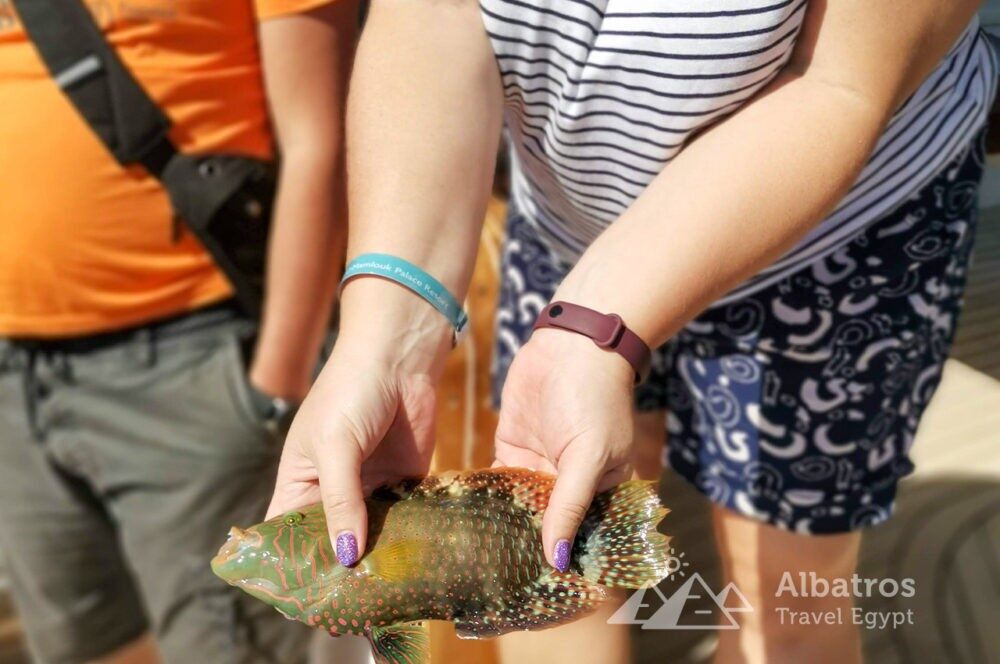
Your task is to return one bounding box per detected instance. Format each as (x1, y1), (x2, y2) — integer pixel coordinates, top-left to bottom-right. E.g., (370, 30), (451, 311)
(250, 0), (358, 400)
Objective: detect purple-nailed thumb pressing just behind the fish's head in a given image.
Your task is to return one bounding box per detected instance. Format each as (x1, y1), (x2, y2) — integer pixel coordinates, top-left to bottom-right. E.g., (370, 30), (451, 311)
(316, 445), (368, 567)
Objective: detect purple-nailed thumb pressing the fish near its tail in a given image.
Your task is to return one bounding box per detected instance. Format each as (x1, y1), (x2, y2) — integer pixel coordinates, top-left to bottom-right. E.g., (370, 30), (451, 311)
(542, 446), (604, 572)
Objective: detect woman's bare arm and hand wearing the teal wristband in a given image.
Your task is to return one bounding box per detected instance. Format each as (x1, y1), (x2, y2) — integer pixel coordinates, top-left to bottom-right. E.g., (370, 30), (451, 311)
(269, 0), (502, 564)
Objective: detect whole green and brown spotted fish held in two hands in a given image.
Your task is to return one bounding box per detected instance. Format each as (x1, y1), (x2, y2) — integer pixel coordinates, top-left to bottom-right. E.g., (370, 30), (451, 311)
(211, 468), (670, 664)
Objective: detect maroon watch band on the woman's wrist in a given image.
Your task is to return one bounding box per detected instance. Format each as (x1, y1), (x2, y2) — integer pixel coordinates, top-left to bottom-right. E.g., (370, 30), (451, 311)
(531, 302), (650, 384)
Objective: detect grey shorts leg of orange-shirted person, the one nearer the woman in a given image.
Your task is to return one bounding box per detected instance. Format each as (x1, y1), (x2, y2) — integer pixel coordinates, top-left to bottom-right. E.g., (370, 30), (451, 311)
(59, 314), (311, 664)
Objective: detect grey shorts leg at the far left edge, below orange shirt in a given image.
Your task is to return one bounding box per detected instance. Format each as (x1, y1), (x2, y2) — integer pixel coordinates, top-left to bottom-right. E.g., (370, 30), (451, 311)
(0, 341), (150, 664)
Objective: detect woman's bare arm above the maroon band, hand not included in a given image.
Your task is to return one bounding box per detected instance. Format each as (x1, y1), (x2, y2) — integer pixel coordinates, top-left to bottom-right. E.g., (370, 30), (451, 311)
(559, 0), (979, 345)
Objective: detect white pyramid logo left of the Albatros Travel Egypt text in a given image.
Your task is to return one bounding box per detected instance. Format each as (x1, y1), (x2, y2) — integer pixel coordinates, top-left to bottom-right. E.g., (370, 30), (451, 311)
(608, 573), (753, 630)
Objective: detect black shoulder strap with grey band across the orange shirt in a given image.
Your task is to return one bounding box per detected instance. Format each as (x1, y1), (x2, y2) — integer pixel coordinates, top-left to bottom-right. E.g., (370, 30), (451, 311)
(12, 0), (176, 177)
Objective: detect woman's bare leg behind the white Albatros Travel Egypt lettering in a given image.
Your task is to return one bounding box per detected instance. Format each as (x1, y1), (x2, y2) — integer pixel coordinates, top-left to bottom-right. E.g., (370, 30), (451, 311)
(712, 506), (861, 664)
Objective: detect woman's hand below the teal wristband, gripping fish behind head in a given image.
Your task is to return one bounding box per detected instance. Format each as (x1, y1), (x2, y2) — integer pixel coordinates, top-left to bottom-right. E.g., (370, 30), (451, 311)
(267, 279), (450, 566)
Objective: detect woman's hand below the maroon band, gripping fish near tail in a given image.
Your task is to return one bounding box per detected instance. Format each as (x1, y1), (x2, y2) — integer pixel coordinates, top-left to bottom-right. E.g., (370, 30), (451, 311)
(496, 329), (634, 570)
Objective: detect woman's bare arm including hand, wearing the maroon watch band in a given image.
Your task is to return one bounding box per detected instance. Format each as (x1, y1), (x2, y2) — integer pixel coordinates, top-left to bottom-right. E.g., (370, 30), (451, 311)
(520, 0), (979, 564)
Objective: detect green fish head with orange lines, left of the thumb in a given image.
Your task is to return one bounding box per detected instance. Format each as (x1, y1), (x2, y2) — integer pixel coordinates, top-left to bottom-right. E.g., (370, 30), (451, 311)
(212, 508), (342, 618)
